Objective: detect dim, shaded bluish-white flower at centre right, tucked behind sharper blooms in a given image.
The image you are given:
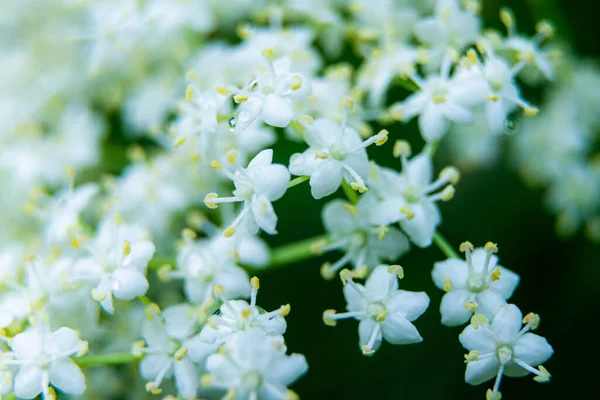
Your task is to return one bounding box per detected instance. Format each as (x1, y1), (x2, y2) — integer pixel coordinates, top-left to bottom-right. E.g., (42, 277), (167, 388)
(321, 193), (410, 279)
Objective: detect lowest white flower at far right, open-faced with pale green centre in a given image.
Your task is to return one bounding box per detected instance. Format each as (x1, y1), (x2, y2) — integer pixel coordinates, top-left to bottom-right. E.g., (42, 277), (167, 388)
(459, 304), (554, 400)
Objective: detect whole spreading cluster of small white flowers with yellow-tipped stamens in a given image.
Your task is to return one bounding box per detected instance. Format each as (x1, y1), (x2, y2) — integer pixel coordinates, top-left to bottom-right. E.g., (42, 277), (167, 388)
(0, 0), (564, 400)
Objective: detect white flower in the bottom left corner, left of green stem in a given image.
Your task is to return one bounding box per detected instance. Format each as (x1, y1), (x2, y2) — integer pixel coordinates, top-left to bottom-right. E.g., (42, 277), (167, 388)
(0, 327), (88, 399)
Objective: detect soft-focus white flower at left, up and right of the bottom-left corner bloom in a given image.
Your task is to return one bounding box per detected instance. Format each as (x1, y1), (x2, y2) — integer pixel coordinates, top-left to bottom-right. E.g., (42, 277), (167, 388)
(73, 216), (155, 314)
